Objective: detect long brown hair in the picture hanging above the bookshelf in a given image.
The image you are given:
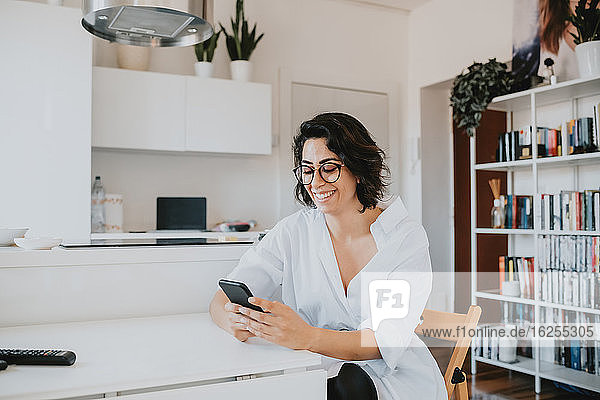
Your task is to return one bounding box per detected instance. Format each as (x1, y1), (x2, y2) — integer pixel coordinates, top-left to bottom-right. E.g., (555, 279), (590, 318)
(539, 0), (571, 54)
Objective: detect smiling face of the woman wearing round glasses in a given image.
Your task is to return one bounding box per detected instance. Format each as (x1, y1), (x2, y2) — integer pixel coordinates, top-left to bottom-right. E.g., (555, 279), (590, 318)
(301, 138), (360, 214)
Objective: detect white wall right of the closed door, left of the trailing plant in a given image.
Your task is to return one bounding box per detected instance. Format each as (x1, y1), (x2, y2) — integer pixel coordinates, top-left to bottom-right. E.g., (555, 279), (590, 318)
(402, 0), (513, 312)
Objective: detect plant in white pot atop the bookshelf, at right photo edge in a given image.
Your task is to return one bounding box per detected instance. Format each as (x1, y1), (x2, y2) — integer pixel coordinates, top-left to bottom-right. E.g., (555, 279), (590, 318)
(568, 0), (600, 78)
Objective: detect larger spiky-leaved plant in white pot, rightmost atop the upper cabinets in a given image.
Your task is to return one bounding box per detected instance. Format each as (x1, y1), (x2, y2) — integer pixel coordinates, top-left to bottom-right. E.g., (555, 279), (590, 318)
(220, 0), (264, 81)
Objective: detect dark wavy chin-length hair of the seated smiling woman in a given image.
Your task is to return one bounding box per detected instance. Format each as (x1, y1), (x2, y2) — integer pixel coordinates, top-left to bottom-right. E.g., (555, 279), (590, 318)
(292, 113), (390, 213)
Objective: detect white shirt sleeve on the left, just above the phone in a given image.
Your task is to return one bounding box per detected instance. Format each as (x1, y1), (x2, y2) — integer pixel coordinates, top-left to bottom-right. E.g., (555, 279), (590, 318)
(227, 222), (286, 299)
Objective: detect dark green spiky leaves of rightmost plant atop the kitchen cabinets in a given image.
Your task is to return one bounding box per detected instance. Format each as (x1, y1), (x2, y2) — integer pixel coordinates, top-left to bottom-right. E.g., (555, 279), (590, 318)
(219, 0), (264, 61)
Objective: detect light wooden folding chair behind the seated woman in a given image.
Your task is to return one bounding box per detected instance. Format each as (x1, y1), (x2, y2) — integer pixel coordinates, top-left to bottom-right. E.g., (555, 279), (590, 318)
(415, 306), (481, 400)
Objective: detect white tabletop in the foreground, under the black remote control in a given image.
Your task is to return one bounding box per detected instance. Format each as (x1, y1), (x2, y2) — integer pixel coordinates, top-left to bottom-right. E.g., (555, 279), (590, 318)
(0, 314), (321, 400)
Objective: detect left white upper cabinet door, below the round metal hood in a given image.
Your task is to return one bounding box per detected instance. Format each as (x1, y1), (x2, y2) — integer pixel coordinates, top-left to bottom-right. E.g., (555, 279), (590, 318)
(92, 67), (185, 151)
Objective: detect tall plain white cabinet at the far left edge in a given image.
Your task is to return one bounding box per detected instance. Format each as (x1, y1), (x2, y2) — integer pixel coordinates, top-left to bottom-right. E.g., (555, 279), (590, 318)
(0, 0), (92, 242)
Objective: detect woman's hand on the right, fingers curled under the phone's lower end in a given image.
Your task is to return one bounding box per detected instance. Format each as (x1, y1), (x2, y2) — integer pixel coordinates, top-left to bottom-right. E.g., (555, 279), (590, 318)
(239, 297), (315, 350)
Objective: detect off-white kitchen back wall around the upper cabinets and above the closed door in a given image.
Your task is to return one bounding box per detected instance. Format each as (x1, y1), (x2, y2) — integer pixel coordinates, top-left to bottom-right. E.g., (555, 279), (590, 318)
(92, 0), (408, 229)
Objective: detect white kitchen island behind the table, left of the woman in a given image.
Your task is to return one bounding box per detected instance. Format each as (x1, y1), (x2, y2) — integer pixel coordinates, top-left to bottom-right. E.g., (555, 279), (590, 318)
(0, 243), (251, 327)
